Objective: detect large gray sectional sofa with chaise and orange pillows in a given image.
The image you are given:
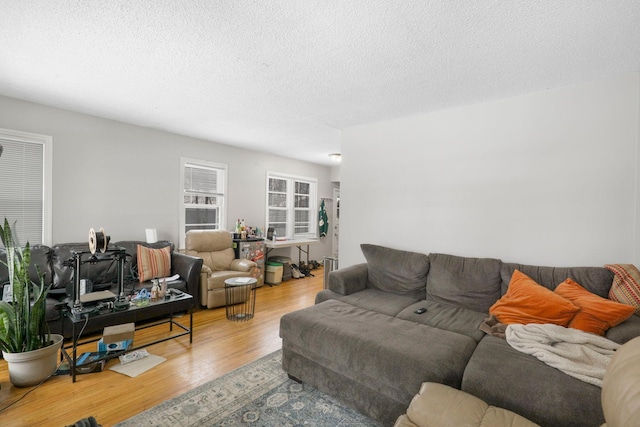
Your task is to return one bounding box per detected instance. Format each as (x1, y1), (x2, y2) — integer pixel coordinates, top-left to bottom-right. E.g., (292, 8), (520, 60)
(280, 244), (640, 427)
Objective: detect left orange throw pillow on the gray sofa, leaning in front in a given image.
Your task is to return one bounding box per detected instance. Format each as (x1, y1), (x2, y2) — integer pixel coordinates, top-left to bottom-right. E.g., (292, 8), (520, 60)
(489, 270), (580, 326)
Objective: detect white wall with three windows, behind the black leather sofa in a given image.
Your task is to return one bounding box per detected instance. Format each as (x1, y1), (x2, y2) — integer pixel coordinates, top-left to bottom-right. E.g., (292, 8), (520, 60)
(0, 96), (334, 260)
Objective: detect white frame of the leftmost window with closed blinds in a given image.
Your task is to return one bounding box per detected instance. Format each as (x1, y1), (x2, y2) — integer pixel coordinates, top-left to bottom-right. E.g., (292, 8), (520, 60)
(0, 128), (53, 246)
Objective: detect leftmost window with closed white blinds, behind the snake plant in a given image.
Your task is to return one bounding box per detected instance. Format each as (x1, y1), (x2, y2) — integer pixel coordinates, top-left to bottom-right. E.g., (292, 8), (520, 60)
(0, 129), (53, 245)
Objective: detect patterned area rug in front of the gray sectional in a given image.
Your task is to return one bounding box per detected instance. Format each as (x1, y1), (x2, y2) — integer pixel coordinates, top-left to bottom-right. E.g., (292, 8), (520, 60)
(118, 350), (381, 427)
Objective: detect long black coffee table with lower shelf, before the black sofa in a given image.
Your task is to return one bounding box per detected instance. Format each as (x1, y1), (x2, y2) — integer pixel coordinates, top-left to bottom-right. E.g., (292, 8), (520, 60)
(62, 293), (194, 382)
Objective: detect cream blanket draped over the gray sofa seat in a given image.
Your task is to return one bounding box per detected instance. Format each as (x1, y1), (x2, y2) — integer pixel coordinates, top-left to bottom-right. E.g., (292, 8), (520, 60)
(506, 324), (620, 387)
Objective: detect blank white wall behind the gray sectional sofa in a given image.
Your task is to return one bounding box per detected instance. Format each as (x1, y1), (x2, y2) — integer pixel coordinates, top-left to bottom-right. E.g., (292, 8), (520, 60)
(340, 73), (640, 267)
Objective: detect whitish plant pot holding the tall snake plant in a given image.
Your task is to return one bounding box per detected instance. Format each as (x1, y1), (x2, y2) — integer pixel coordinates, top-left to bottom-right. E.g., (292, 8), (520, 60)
(2, 334), (64, 387)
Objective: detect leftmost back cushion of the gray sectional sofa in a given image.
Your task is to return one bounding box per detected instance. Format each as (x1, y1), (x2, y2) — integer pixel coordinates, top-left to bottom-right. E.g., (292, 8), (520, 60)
(360, 243), (429, 299)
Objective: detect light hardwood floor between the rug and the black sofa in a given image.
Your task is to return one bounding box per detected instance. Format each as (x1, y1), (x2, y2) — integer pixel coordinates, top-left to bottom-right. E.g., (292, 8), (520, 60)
(0, 268), (323, 427)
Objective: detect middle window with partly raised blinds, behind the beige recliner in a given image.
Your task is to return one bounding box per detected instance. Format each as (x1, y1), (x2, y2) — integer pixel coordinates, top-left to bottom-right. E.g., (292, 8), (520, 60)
(180, 158), (227, 249)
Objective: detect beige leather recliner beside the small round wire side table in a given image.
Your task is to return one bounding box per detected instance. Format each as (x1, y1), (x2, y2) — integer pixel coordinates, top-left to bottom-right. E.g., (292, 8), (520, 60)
(185, 230), (257, 308)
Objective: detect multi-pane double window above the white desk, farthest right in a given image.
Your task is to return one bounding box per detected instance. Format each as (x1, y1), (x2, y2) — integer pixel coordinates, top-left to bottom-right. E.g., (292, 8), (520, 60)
(267, 172), (317, 239)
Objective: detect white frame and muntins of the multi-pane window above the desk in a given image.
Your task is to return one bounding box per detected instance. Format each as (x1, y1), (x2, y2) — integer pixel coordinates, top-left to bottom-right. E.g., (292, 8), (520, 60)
(265, 171), (318, 240)
